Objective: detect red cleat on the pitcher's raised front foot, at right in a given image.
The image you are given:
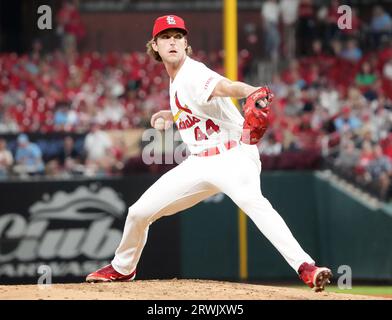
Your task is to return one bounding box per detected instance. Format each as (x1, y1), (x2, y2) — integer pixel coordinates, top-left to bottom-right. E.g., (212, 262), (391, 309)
(298, 262), (332, 292)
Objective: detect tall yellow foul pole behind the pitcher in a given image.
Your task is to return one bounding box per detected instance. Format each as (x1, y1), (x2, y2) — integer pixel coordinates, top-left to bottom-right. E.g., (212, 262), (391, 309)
(223, 0), (248, 280)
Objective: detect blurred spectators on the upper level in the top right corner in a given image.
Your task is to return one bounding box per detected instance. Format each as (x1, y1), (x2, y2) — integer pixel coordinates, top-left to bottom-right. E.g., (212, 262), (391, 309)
(258, 0), (392, 62)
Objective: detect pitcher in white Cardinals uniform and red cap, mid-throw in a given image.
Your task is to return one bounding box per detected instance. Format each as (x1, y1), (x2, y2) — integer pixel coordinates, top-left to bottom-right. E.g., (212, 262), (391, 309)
(86, 15), (332, 291)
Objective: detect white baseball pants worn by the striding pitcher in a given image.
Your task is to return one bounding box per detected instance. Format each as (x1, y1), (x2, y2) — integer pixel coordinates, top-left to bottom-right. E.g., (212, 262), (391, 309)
(112, 143), (314, 275)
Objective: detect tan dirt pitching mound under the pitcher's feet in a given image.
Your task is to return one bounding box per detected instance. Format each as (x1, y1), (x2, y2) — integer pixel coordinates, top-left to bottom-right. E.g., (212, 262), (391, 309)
(0, 279), (382, 300)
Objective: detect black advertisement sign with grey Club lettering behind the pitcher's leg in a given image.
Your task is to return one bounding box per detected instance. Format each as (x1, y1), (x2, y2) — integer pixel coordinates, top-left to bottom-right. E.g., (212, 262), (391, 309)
(0, 175), (179, 283)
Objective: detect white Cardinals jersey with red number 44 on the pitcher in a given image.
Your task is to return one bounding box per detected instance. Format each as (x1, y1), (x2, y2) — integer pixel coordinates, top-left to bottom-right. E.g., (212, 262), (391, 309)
(170, 57), (244, 154)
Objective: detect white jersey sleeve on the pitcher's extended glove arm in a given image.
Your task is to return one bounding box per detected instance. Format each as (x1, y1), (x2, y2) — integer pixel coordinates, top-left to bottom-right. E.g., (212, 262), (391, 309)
(191, 63), (224, 105)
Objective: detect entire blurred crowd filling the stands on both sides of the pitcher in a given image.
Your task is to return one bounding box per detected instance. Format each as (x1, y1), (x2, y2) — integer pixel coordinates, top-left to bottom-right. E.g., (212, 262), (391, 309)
(0, 0), (392, 199)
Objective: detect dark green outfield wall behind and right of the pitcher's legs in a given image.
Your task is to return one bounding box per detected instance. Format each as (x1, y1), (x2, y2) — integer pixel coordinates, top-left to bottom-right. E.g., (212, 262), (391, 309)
(181, 172), (392, 281)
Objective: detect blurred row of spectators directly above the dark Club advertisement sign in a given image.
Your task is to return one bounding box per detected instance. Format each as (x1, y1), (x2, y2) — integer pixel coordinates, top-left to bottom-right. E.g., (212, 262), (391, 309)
(0, 123), (127, 180)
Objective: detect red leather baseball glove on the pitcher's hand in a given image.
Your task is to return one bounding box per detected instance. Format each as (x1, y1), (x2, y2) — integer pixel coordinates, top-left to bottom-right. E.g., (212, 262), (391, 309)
(241, 87), (274, 144)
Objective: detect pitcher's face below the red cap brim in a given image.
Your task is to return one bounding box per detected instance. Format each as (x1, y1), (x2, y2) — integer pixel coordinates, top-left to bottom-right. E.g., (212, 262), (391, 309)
(153, 29), (188, 64)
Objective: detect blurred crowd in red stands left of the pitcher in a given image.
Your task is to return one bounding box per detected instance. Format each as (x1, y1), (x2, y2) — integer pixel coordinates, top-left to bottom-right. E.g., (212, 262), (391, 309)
(0, 47), (249, 178)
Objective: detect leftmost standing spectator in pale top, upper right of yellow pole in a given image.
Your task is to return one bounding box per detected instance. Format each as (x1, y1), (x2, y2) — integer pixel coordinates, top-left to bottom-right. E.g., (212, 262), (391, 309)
(261, 0), (280, 63)
